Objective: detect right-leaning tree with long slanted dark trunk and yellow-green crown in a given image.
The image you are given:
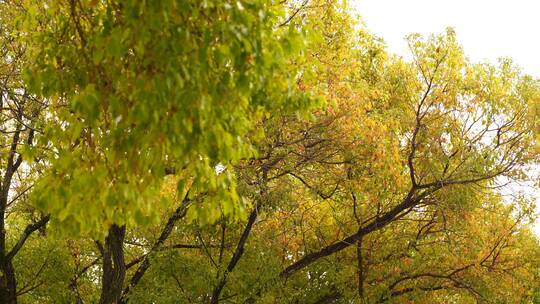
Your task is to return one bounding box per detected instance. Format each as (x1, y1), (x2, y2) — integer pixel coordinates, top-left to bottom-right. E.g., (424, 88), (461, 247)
(281, 28), (538, 278)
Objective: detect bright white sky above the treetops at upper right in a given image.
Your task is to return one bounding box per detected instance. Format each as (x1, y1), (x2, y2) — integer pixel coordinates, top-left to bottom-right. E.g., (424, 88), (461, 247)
(349, 0), (540, 236)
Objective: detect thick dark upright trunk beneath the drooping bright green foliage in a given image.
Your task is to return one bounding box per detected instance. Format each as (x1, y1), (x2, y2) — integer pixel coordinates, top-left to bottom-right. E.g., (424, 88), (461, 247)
(99, 225), (126, 304)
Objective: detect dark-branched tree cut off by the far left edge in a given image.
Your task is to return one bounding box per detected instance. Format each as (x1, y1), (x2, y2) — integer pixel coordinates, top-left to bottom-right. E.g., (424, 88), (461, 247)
(0, 6), (49, 304)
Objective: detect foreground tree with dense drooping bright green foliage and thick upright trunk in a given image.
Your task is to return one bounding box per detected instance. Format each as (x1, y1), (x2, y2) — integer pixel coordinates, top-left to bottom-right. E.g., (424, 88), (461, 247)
(17, 0), (320, 303)
